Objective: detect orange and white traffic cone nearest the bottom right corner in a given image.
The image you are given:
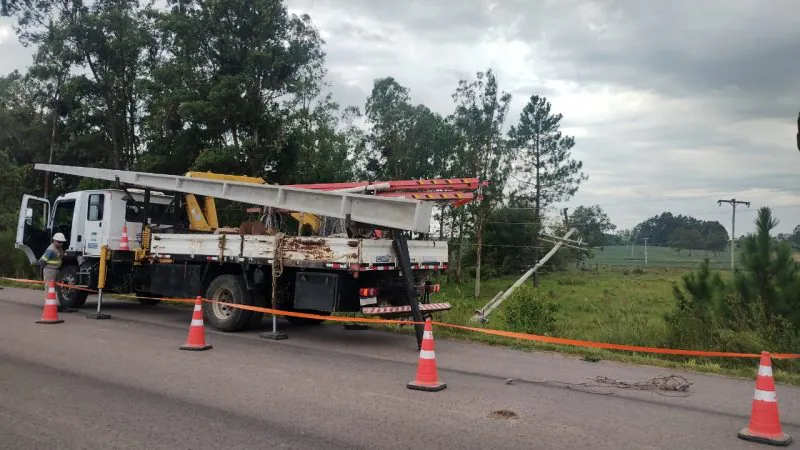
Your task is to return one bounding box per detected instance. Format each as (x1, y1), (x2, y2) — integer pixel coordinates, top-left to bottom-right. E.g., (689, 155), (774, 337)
(739, 352), (792, 445)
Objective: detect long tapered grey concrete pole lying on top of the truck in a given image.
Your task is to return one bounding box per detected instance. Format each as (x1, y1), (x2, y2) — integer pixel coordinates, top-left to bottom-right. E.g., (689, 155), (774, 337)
(34, 164), (433, 233)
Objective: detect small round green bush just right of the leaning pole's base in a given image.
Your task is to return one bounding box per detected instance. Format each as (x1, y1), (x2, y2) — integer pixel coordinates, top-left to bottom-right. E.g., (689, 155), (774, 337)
(499, 285), (559, 334)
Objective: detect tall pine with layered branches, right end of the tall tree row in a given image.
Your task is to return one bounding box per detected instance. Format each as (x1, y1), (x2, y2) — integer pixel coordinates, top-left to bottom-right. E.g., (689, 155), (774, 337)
(508, 95), (588, 284)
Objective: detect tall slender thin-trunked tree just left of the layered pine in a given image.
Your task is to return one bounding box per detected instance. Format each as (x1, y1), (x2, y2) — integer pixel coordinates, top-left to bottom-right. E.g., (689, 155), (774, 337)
(451, 69), (511, 297)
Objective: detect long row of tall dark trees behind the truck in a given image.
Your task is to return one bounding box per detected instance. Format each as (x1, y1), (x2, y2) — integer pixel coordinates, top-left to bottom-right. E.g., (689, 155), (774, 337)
(0, 0), (588, 295)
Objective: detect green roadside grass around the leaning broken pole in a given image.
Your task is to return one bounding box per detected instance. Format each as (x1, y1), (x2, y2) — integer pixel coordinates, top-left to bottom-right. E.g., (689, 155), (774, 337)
(412, 268), (800, 384)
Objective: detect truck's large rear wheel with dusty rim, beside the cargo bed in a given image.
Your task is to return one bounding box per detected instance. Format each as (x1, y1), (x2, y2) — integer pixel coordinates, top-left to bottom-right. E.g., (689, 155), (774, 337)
(203, 275), (253, 331)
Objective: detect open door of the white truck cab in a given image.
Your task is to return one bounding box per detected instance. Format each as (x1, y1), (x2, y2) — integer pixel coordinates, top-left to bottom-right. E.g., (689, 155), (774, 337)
(15, 195), (52, 264)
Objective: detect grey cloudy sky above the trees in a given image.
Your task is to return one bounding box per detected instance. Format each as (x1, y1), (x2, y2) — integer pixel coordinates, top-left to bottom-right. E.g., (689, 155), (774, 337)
(0, 0), (800, 235)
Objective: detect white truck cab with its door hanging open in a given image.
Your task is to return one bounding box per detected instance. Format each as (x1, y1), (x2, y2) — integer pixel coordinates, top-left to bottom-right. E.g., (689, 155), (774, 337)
(16, 189), (172, 264)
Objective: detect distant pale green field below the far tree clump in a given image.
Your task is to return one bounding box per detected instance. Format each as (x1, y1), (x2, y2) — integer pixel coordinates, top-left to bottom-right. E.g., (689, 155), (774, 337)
(586, 245), (731, 269)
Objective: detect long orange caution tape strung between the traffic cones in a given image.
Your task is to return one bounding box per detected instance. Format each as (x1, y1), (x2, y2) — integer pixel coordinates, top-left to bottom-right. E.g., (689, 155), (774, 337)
(3, 277), (800, 359)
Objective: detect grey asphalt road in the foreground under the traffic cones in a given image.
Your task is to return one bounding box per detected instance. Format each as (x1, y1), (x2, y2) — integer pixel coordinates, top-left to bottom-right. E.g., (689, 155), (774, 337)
(0, 288), (800, 450)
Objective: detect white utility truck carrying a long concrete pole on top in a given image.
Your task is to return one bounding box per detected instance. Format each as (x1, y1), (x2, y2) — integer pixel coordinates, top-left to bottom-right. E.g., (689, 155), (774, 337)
(16, 164), (472, 340)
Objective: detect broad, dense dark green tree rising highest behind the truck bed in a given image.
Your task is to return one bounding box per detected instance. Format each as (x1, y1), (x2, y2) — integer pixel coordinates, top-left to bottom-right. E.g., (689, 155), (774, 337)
(143, 0), (326, 178)
